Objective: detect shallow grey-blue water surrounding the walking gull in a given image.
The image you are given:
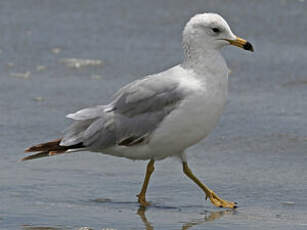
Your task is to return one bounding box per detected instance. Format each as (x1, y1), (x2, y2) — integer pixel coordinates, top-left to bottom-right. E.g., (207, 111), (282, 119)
(0, 0), (307, 230)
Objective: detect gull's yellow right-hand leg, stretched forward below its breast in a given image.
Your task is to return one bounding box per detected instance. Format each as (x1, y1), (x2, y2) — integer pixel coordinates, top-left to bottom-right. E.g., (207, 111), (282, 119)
(182, 162), (237, 208)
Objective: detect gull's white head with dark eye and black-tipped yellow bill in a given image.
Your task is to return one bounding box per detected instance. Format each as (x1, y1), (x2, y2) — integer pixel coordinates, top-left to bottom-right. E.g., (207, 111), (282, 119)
(183, 13), (254, 52)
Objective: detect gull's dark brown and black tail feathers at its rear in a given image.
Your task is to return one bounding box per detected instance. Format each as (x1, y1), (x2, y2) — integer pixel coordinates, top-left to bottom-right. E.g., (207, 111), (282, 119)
(21, 139), (84, 161)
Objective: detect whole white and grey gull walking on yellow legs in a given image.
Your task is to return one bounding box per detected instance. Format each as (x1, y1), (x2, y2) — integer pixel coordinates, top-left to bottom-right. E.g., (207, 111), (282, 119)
(22, 13), (253, 208)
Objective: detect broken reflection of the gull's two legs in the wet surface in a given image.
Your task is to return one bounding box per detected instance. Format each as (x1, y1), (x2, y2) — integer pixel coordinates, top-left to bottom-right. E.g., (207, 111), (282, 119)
(137, 207), (236, 230)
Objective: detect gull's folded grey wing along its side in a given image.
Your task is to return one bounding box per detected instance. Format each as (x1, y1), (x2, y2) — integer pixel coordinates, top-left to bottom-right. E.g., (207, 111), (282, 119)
(61, 75), (185, 150)
